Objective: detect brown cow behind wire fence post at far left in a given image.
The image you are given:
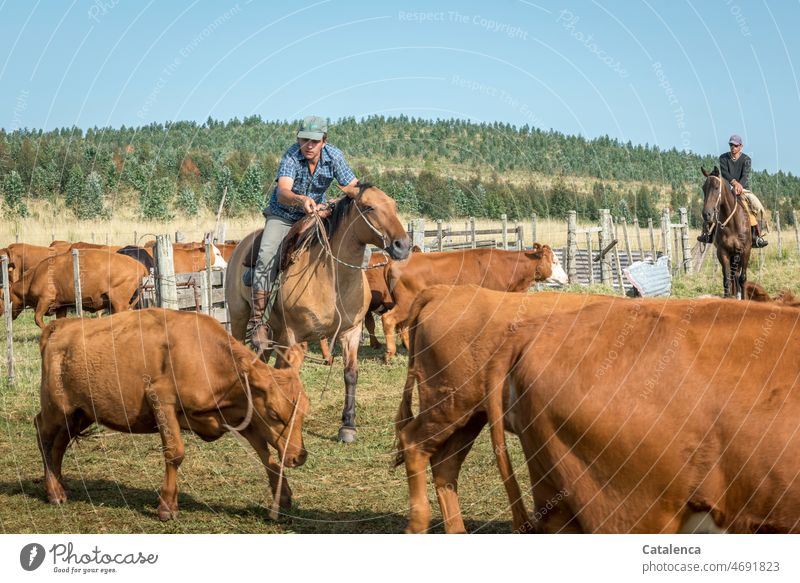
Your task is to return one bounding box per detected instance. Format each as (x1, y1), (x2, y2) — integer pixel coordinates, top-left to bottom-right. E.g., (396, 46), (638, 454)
(0, 249), (147, 329)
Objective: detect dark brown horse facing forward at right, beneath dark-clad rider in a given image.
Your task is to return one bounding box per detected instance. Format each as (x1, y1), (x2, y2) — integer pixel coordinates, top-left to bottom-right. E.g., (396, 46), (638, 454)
(700, 166), (753, 300)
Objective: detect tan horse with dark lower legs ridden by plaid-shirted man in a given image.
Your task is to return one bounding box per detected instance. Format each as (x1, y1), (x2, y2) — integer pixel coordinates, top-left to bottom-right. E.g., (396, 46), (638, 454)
(225, 184), (411, 442)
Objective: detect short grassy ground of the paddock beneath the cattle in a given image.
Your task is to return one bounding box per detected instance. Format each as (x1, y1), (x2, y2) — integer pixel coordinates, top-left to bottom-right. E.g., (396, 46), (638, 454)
(0, 227), (800, 533)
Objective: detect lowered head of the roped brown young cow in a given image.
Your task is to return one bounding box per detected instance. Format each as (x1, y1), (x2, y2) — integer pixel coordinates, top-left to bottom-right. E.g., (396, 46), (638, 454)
(249, 360), (308, 468)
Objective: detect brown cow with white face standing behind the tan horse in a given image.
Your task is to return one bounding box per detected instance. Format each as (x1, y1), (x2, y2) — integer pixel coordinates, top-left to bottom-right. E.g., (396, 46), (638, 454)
(381, 243), (567, 362)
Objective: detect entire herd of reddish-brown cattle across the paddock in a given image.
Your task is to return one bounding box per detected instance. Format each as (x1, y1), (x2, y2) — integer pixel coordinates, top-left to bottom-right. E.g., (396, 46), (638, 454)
(0, 232), (800, 533)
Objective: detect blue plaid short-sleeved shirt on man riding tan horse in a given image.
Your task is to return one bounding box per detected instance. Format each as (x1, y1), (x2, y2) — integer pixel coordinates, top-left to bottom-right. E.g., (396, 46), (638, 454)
(264, 144), (356, 222)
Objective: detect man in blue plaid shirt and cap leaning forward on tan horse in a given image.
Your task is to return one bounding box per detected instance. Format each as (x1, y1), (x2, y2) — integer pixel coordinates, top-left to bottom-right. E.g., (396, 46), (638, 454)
(247, 116), (358, 350)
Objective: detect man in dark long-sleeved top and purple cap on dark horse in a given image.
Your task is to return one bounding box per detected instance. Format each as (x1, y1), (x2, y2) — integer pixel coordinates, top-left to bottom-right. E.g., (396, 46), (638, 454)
(697, 134), (769, 247)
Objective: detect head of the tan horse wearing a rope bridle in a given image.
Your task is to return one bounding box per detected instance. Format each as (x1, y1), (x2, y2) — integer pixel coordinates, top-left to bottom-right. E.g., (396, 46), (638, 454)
(353, 183), (411, 260)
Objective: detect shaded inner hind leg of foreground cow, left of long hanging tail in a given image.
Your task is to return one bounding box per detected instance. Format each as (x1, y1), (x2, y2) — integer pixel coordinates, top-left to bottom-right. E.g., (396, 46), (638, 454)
(431, 413), (486, 534)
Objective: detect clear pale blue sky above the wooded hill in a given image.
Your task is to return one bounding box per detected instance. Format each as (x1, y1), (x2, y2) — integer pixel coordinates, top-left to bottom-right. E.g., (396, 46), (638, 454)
(0, 0), (800, 174)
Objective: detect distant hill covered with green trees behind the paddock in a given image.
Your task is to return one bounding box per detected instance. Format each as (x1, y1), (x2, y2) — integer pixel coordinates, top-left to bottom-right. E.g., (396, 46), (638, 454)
(0, 116), (800, 224)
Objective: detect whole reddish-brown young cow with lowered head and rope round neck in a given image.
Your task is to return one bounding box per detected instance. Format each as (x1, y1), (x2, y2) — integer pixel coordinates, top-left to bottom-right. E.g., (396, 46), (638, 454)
(34, 308), (308, 520)
